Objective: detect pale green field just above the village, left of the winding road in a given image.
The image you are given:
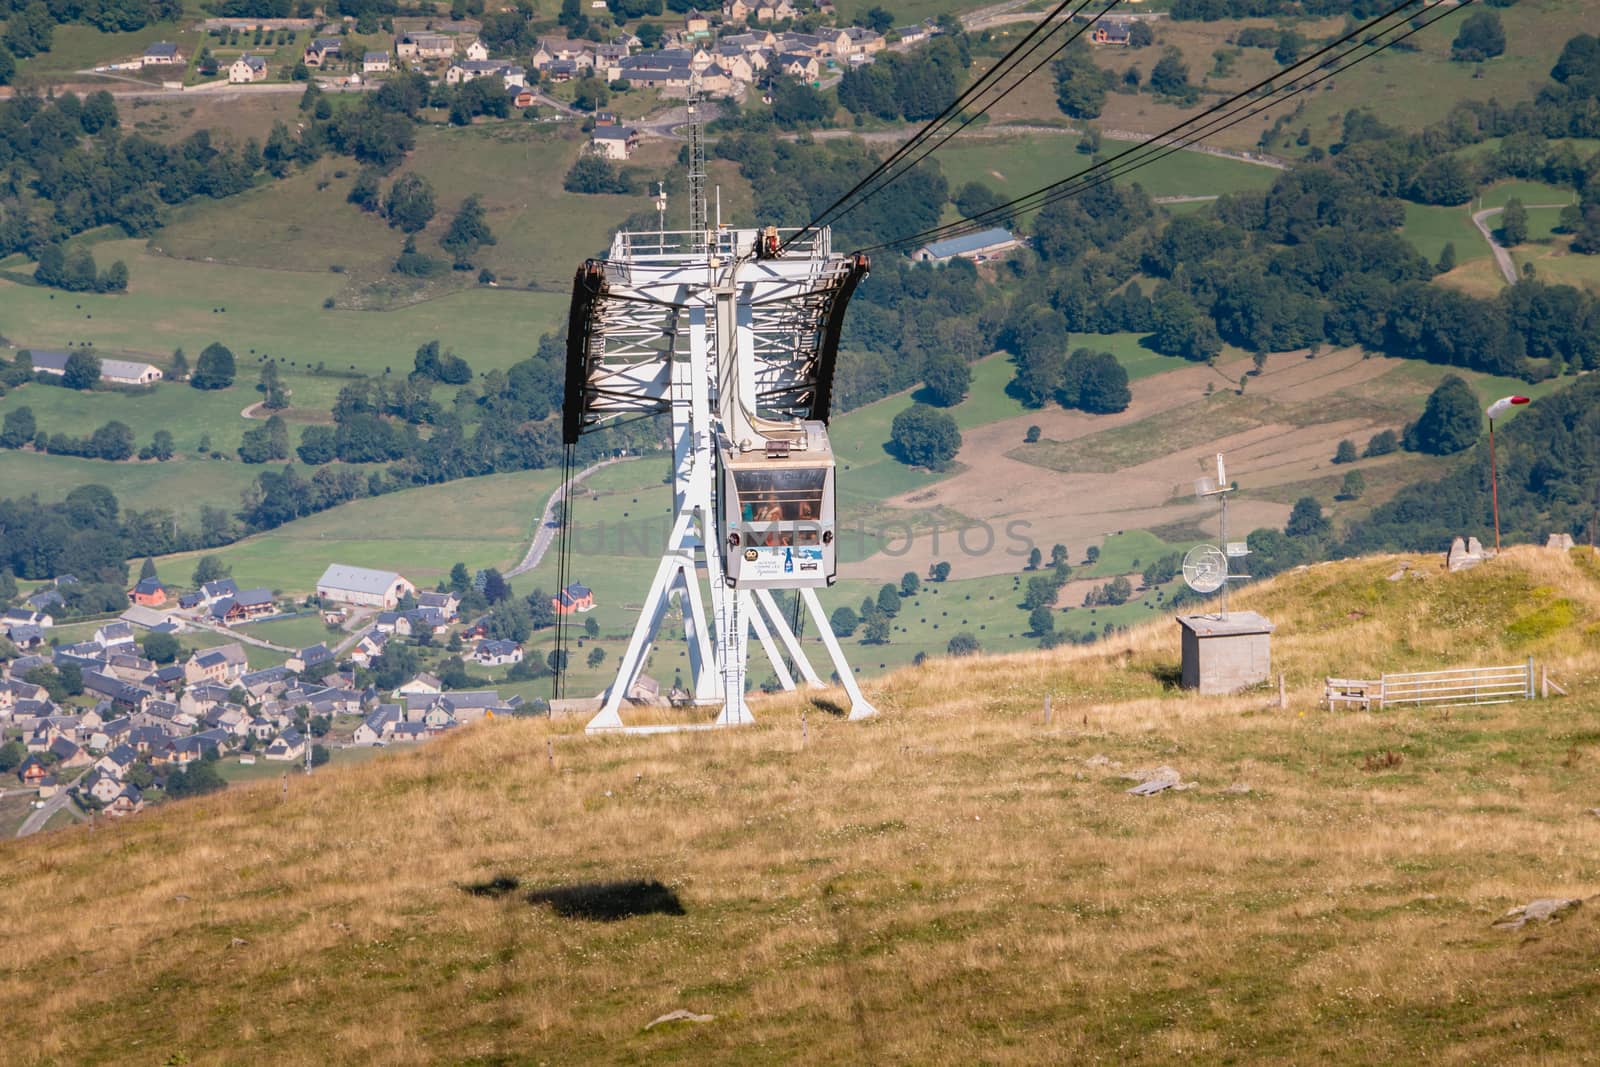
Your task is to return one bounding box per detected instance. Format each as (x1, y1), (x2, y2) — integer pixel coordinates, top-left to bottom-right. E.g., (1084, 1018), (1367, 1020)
(158, 464), (558, 595)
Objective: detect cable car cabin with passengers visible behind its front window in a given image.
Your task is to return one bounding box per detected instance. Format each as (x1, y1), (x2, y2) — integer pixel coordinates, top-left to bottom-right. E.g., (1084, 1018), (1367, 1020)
(720, 422), (838, 589)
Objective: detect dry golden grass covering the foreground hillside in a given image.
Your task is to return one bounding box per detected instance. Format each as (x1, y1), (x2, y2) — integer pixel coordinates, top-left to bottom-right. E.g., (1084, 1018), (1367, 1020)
(0, 549), (1600, 1064)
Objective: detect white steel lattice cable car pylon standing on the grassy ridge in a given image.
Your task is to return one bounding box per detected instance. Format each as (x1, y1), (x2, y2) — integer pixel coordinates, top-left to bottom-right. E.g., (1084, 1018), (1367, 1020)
(563, 229), (874, 731)
